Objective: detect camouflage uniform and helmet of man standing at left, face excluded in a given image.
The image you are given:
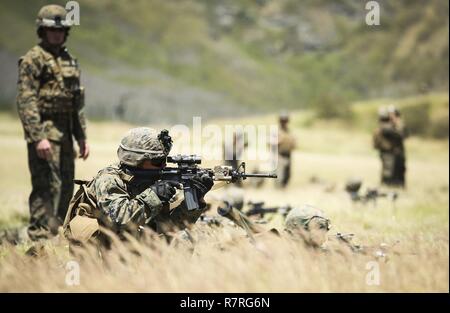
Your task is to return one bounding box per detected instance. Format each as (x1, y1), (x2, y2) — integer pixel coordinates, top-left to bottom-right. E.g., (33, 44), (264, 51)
(16, 5), (86, 239)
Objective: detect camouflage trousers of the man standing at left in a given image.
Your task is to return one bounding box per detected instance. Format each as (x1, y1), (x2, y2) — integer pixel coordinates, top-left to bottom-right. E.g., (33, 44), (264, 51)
(28, 140), (75, 240)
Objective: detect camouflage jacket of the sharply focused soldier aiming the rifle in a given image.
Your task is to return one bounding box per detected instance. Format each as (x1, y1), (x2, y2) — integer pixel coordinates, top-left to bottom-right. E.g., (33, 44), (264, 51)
(79, 163), (205, 231)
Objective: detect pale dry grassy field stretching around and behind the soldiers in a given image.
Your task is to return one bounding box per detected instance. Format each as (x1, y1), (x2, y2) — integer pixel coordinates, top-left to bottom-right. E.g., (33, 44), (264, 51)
(0, 113), (449, 292)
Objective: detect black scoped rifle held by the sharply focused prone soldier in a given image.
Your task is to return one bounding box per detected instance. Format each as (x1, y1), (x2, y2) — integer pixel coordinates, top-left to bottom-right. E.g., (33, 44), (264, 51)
(128, 154), (277, 211)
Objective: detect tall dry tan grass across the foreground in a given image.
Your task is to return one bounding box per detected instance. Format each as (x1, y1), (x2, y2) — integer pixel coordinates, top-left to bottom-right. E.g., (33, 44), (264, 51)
(0, 223), (448, 292)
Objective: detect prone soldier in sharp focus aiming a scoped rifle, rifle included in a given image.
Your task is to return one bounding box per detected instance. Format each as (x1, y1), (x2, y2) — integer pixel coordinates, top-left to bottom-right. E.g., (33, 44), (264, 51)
(63, 127), (276, 247)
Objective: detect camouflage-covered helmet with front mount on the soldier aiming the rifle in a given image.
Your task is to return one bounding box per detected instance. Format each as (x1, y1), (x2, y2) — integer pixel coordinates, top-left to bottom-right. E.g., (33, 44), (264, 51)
(117, 127), (172, 167)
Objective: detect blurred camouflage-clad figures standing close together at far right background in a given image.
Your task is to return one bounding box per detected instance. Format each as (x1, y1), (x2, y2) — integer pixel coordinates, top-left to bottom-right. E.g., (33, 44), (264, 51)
(373, 108), (406, 186)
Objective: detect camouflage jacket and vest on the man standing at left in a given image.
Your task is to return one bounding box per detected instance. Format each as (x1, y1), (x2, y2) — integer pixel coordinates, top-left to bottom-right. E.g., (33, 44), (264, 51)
(16, 44), (86, 143)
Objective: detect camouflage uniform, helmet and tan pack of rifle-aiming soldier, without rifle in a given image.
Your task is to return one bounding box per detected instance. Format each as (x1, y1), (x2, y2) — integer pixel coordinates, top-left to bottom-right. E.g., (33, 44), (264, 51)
(64, 127), (206, 243)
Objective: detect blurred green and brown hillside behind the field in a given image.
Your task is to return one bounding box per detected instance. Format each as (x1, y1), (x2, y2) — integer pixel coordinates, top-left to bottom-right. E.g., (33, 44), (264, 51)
(0, 0), (449, 138)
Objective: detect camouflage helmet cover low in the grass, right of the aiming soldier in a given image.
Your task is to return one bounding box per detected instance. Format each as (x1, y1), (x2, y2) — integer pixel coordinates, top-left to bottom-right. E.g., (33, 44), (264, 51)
(285, 205), (330, 231)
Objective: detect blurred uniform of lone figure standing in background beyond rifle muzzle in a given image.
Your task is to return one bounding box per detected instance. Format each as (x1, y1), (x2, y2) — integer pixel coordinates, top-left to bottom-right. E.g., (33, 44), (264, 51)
(276, 116), (296, 188)
